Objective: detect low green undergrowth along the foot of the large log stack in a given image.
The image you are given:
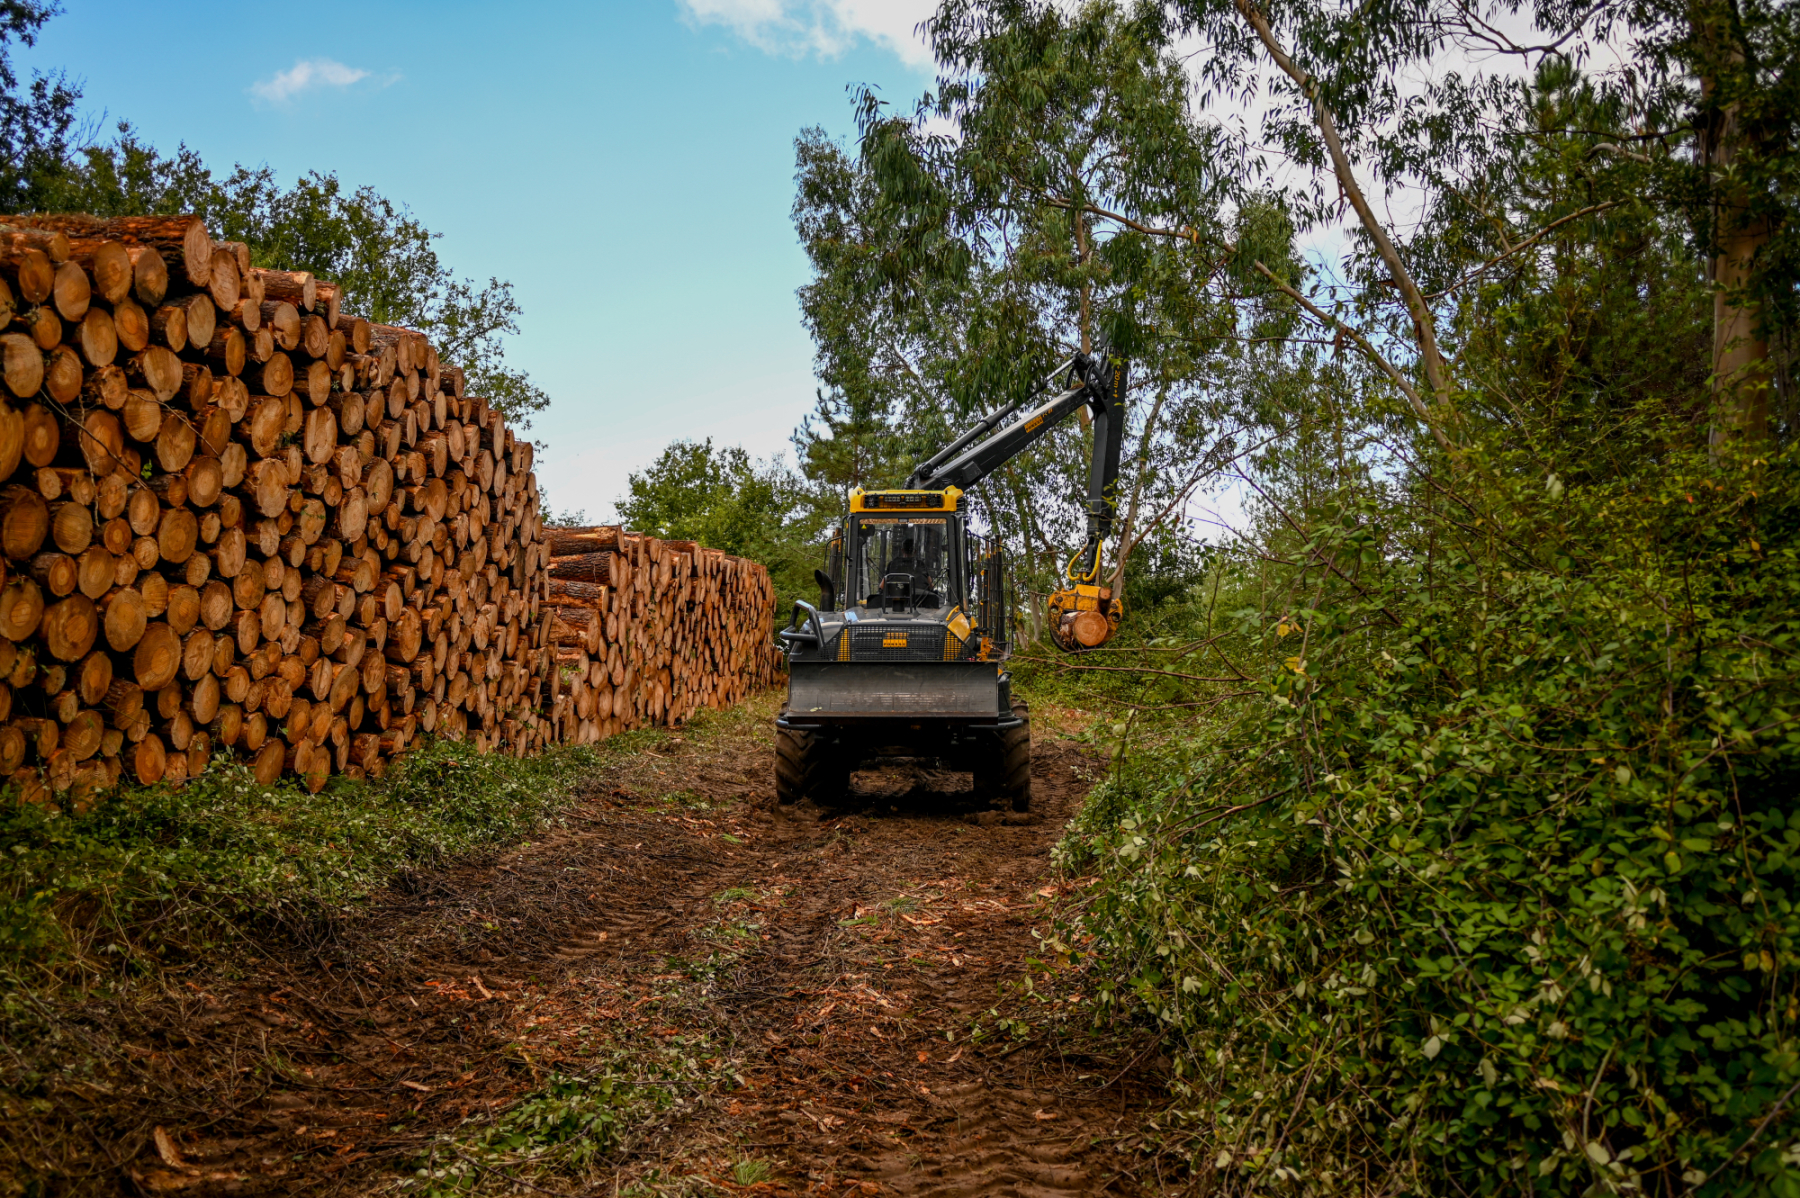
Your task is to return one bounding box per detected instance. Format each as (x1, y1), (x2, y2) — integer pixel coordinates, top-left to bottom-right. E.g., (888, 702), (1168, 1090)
(0, 741), (594, 977)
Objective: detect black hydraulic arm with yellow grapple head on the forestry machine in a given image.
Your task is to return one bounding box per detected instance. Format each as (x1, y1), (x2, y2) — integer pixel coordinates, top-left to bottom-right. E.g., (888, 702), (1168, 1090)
(907, 353), (1127, 649)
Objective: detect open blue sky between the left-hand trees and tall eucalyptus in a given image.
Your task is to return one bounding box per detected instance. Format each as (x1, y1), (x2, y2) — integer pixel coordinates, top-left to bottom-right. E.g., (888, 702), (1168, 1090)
(22, 0), (931, 518)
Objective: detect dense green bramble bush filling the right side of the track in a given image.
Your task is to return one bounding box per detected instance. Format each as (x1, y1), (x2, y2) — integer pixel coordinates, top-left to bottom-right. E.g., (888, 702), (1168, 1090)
(1058, 442), (1800, 1194)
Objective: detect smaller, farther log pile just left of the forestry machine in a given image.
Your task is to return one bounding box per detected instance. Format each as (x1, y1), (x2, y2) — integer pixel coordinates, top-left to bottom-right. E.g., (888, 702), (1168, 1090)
(544, 525), (781, 739)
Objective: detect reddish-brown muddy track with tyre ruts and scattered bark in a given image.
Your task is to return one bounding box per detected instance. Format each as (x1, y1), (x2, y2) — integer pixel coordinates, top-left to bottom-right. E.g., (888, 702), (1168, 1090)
(10, 703), (1166, 1196)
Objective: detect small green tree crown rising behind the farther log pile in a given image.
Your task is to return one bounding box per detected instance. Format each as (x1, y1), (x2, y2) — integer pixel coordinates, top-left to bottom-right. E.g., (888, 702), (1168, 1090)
(617, 437), (835, 619)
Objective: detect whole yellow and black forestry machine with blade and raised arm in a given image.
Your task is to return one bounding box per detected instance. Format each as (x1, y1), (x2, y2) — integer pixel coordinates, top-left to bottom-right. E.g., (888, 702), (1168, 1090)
(776, 353), (1125, 811)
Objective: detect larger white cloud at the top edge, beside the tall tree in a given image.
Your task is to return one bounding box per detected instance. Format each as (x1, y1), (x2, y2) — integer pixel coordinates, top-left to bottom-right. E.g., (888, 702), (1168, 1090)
(680, 0), (938, 70)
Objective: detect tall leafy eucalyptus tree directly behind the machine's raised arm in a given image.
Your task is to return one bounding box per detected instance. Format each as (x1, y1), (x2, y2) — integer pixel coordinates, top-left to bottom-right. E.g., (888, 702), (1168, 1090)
(796, 4), (1287, 615)
